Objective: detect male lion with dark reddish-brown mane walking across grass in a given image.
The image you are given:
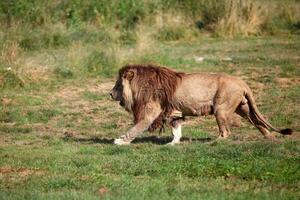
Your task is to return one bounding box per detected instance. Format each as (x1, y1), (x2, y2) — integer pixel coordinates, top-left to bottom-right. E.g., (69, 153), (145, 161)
(110, 64), (292, 145)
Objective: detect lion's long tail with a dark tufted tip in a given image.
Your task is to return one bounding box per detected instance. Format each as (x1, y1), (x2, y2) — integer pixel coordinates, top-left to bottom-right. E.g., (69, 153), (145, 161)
(245, 88), (293, 135)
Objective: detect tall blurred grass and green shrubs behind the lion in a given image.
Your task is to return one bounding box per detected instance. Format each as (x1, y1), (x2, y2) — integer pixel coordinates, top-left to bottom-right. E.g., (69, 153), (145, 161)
(0, 0), (300, 88)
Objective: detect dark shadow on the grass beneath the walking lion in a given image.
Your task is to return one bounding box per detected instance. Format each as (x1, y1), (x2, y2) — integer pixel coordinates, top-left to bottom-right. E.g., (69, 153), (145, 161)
(63, 136), (212, 145)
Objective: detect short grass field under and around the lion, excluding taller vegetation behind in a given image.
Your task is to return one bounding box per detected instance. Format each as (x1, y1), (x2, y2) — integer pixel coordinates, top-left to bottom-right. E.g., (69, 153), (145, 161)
(0, 34), (300, 199)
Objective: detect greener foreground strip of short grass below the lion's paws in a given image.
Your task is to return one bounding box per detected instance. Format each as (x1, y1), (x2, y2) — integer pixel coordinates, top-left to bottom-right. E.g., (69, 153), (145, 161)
(1, 139), (300, 199)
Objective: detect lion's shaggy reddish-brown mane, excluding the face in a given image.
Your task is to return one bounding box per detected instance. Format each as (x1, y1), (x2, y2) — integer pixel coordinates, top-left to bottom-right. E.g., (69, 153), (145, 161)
(119, 64), (184, 131)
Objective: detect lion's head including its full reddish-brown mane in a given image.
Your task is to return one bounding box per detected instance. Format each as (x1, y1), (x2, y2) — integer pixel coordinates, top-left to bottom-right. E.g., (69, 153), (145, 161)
(110, 65), (183, 131)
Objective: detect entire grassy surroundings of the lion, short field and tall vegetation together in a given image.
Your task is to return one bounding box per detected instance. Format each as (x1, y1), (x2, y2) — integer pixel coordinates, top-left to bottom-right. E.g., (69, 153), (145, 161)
(0, 0), (300, 200)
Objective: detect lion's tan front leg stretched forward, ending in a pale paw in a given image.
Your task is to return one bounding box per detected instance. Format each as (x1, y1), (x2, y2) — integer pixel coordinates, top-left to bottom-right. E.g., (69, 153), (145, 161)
(114, 102), (162, 145)
